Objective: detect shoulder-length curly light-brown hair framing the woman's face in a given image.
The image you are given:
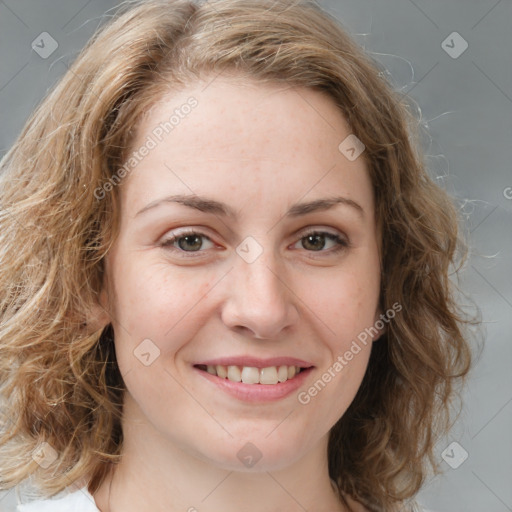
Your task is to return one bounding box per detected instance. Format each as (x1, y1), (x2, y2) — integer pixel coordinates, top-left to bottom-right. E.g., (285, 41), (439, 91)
(0, 0), (472, 510)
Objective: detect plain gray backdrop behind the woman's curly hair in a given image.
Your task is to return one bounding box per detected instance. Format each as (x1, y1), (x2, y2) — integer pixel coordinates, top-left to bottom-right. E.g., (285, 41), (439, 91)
(0, 0), (512, 512)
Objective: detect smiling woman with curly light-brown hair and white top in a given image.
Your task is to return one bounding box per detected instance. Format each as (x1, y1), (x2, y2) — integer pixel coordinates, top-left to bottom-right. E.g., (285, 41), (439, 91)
(0, 0), (470, 512)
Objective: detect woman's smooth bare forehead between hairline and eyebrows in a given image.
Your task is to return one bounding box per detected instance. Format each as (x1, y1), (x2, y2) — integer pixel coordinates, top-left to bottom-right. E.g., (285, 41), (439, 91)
(124, 78), (372, 217)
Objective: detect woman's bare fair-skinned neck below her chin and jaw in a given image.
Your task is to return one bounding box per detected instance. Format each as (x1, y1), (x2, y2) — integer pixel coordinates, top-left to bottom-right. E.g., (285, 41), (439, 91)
(94, 398), (346, 512)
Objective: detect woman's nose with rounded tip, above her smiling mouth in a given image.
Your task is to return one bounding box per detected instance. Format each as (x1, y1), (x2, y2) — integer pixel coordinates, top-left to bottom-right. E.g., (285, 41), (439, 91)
(221, 251), (299, 339)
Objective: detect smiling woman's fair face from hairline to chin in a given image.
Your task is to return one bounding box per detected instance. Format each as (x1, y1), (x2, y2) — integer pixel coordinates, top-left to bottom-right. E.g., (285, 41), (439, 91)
(102, 78), (380, 471)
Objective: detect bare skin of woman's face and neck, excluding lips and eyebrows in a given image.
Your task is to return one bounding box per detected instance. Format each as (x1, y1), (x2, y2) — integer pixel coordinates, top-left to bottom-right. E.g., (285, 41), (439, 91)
(94, 77), (380, 512)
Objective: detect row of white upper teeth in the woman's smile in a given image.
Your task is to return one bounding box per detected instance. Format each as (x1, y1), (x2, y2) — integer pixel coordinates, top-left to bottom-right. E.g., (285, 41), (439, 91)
(206, 365), (300, 385)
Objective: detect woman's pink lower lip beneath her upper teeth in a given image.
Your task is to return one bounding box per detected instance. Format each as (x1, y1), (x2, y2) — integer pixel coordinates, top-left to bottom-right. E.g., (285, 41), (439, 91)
(194, 367), (313, 402)
